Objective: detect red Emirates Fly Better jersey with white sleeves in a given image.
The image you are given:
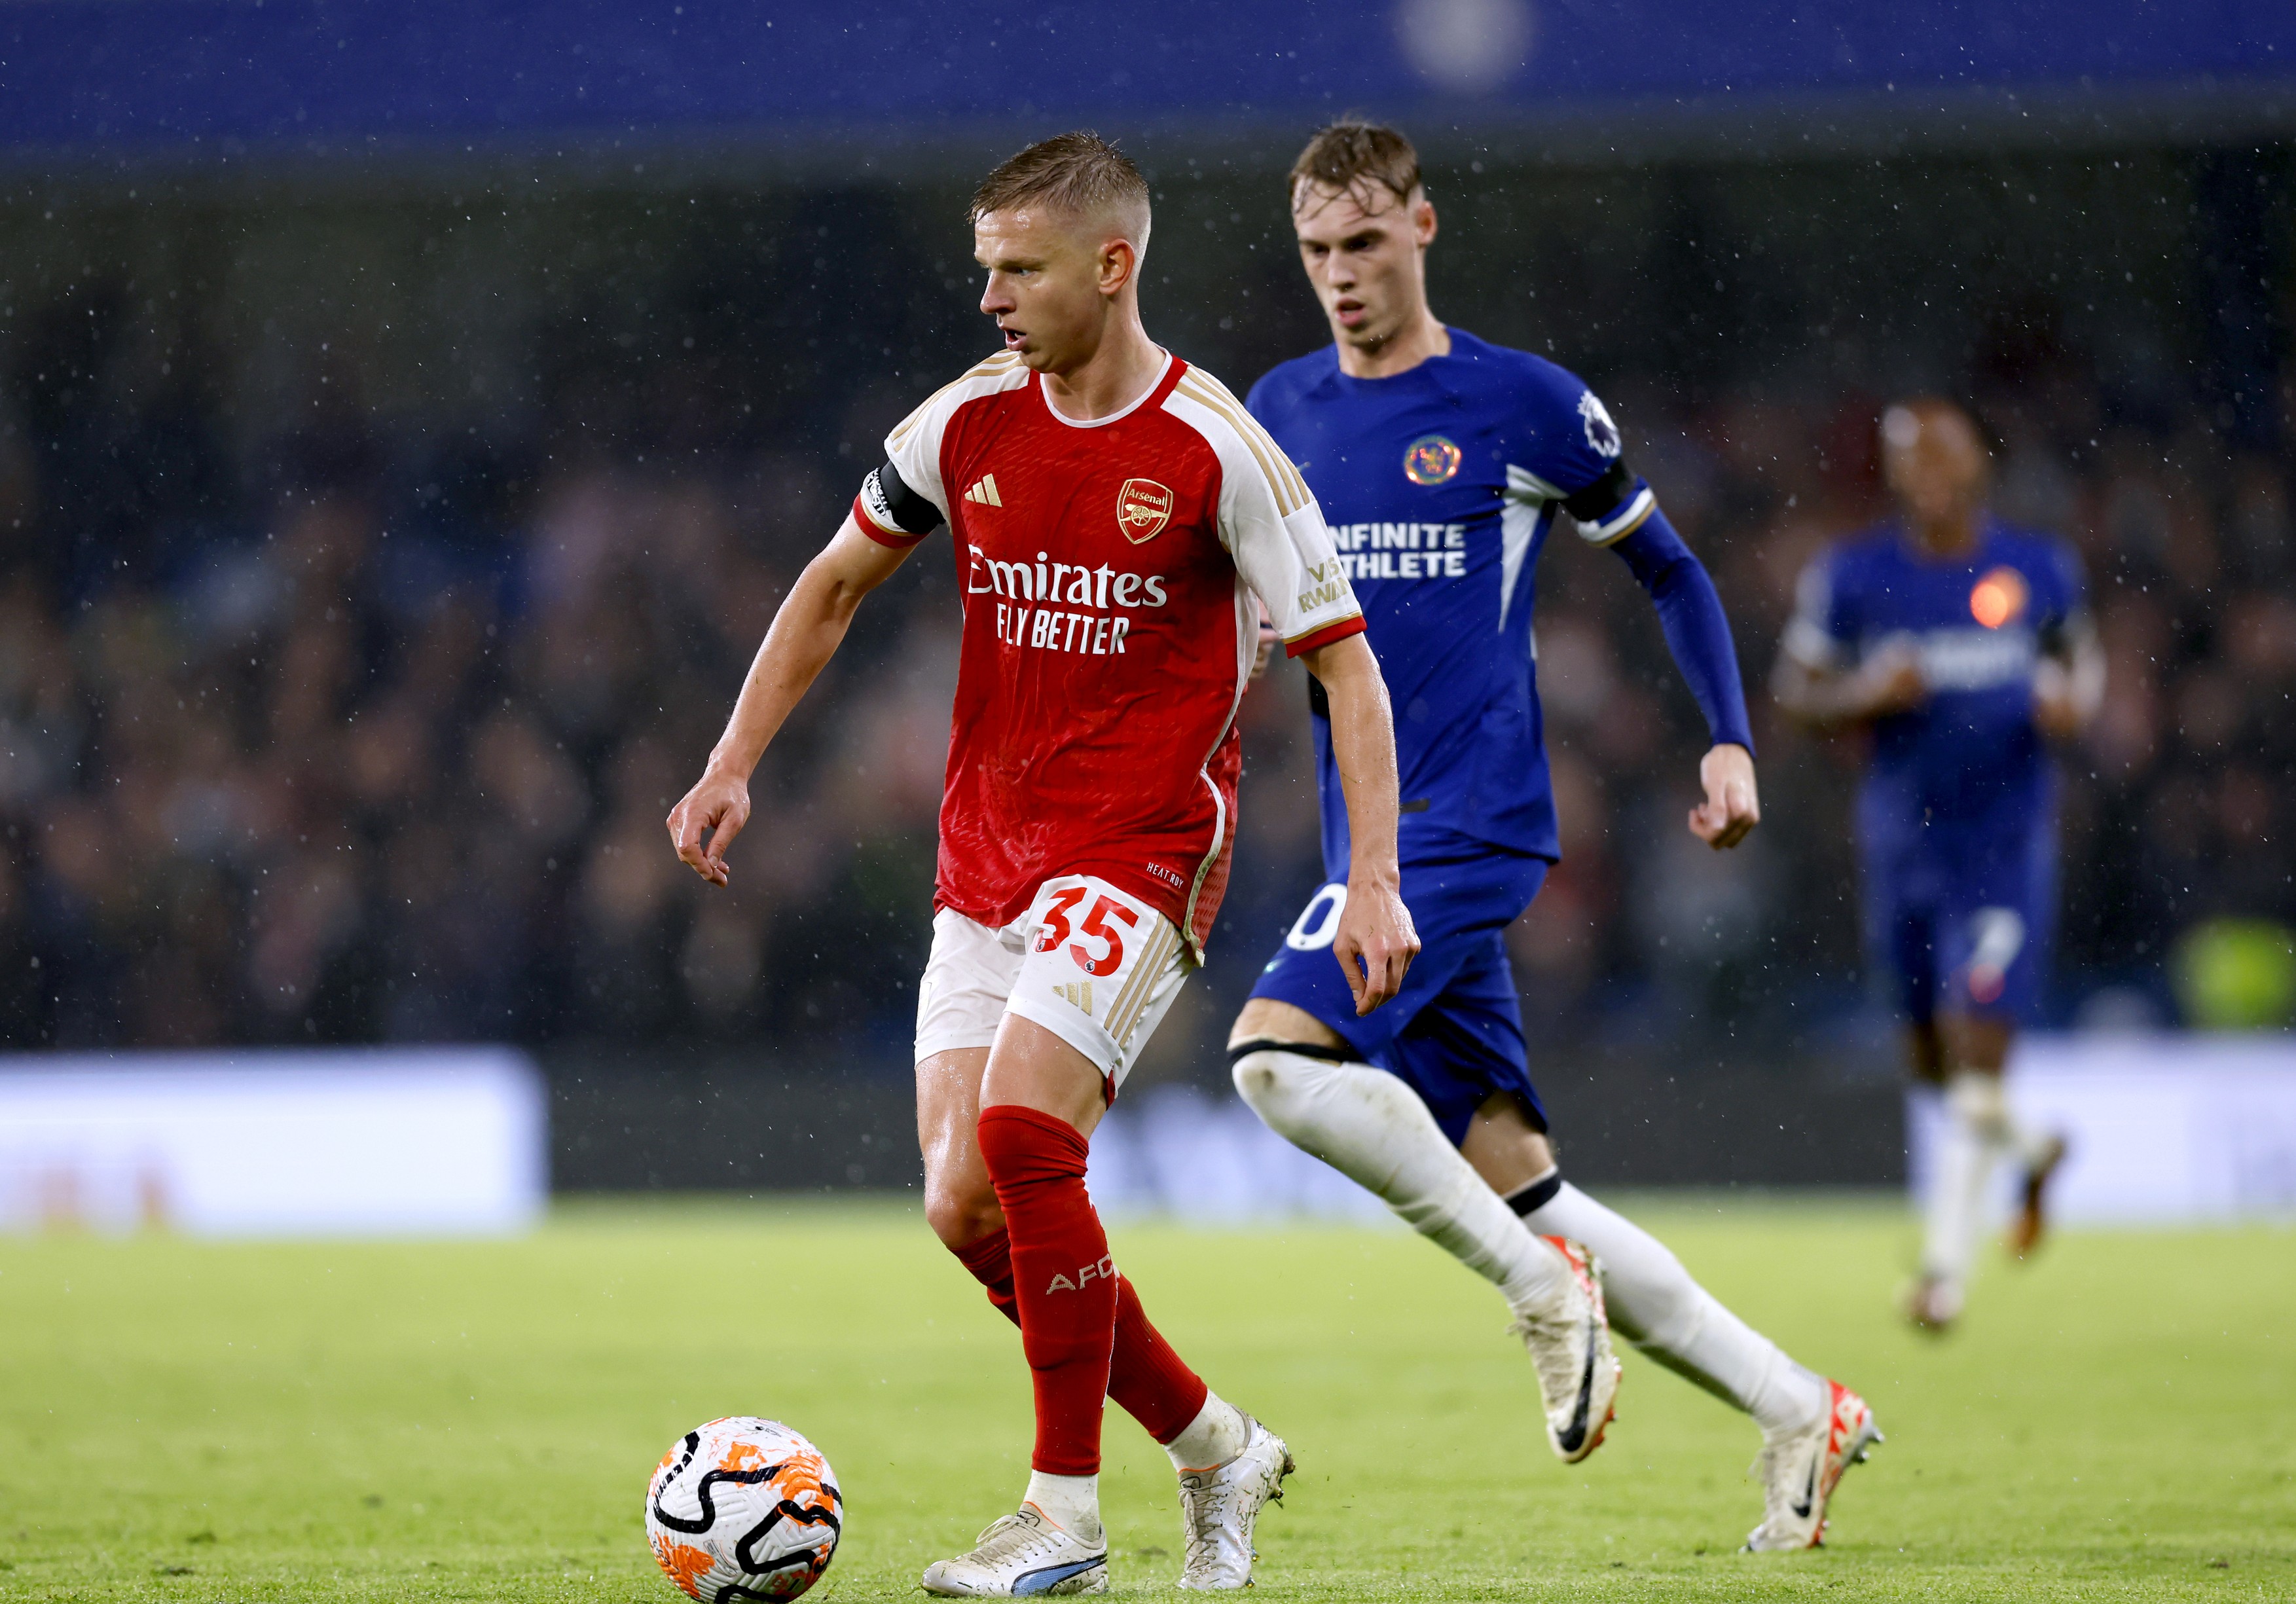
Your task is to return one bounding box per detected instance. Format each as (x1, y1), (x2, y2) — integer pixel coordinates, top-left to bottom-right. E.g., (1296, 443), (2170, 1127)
(854, 354), (1364, 959)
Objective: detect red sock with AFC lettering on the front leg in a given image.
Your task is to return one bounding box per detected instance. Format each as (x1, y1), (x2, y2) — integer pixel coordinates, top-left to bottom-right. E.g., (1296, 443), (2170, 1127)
(980, 1104), (1116, 1476)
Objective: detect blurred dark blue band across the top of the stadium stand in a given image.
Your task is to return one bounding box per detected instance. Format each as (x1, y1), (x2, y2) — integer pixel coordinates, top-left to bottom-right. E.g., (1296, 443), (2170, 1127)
(0, 0), (2296, 170)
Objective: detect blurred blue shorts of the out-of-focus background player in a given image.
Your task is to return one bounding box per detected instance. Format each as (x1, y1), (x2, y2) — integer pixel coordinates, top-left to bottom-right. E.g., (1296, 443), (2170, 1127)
(1867, 819), (2057, 1023)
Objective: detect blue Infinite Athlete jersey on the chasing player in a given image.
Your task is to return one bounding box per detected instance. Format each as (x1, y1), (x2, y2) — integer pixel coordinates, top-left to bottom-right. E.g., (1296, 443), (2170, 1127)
(1247, 328), (1649, 879)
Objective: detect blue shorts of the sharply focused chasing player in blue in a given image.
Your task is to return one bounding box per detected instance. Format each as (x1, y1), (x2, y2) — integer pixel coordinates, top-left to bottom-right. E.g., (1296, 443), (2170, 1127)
(1251, 835), (1550, 1142)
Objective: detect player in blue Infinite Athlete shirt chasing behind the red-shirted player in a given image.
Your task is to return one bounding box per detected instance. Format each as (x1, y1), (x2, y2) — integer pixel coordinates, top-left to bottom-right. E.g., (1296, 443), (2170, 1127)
(1228, 122), (1880, 1549)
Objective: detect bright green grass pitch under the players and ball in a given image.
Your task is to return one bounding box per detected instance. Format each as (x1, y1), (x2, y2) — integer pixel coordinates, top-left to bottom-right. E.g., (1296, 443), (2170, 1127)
(0, 1200), (2296, 1604)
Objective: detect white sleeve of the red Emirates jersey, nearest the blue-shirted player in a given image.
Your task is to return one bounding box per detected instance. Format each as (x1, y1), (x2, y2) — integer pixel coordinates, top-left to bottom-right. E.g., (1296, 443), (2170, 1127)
(1164, 367), (1364, 656)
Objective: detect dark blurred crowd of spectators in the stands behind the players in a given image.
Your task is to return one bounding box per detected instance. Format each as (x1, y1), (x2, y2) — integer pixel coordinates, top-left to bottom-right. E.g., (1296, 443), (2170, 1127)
(0, 162), (2296, 1076)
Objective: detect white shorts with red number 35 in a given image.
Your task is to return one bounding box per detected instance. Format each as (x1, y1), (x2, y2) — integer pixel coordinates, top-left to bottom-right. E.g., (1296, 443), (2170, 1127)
(916, 874), (1196, 1099)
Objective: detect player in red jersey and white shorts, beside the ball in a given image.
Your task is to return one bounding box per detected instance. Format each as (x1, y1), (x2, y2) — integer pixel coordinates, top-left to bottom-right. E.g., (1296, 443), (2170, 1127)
(668, 133), (1419, 1595)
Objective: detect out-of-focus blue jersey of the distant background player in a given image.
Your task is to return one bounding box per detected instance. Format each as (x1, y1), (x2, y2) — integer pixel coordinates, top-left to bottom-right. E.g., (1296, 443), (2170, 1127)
(1784, 519), (2085, 854)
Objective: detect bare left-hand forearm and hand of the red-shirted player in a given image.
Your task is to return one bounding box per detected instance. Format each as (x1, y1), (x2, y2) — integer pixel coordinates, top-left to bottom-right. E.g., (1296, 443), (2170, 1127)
(668, 514), (909, 886)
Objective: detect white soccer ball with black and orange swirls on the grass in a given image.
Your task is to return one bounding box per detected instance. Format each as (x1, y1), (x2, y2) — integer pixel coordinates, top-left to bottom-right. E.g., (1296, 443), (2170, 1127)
(645, 1416), (845, 1604)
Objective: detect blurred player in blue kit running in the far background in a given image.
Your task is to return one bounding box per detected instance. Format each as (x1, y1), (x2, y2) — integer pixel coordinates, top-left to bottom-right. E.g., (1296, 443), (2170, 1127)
(1772, 399), (2105, 1331)
